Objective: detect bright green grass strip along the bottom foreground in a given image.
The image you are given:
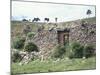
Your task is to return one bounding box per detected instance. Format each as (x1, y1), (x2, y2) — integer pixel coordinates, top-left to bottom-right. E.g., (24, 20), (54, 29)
(11, 57), (96, 74)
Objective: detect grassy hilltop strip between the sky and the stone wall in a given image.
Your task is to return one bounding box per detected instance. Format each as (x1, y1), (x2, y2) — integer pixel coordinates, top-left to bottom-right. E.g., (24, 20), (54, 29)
(11, 17), (96, 35)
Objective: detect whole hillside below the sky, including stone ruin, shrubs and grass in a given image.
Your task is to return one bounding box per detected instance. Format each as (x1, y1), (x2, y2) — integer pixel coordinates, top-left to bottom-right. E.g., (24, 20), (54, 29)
(11, 17), (96, 74)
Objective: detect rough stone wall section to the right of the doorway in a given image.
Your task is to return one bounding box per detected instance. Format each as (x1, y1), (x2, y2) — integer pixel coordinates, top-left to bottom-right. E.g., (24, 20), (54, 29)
(69, 24), (96, 45)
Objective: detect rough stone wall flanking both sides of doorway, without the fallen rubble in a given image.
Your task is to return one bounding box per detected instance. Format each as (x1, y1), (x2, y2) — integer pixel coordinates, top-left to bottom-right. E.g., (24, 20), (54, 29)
(26, 24), (96, 59)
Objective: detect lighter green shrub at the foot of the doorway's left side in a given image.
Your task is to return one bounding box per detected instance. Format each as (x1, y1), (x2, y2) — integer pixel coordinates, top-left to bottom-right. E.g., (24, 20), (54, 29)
(52, 46), (66, 58)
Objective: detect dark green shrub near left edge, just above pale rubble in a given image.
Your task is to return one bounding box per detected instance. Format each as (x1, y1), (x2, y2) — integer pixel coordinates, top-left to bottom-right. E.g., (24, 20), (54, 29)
(13, 38), (25, 49)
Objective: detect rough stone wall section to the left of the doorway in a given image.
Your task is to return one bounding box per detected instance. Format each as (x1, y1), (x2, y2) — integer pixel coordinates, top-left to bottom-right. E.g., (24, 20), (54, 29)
(28, 30), (58, 58)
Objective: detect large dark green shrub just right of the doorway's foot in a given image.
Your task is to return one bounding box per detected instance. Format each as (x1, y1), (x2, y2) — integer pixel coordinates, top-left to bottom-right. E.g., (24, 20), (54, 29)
(69, 42), (84, 58)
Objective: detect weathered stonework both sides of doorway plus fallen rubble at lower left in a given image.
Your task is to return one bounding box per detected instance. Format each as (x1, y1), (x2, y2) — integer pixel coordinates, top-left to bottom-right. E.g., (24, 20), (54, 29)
(12, 22), (96, 64)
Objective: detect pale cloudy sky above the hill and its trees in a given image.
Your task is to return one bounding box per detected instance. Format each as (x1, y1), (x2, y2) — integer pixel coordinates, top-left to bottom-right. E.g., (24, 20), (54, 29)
(12, 1), (95, 22)
